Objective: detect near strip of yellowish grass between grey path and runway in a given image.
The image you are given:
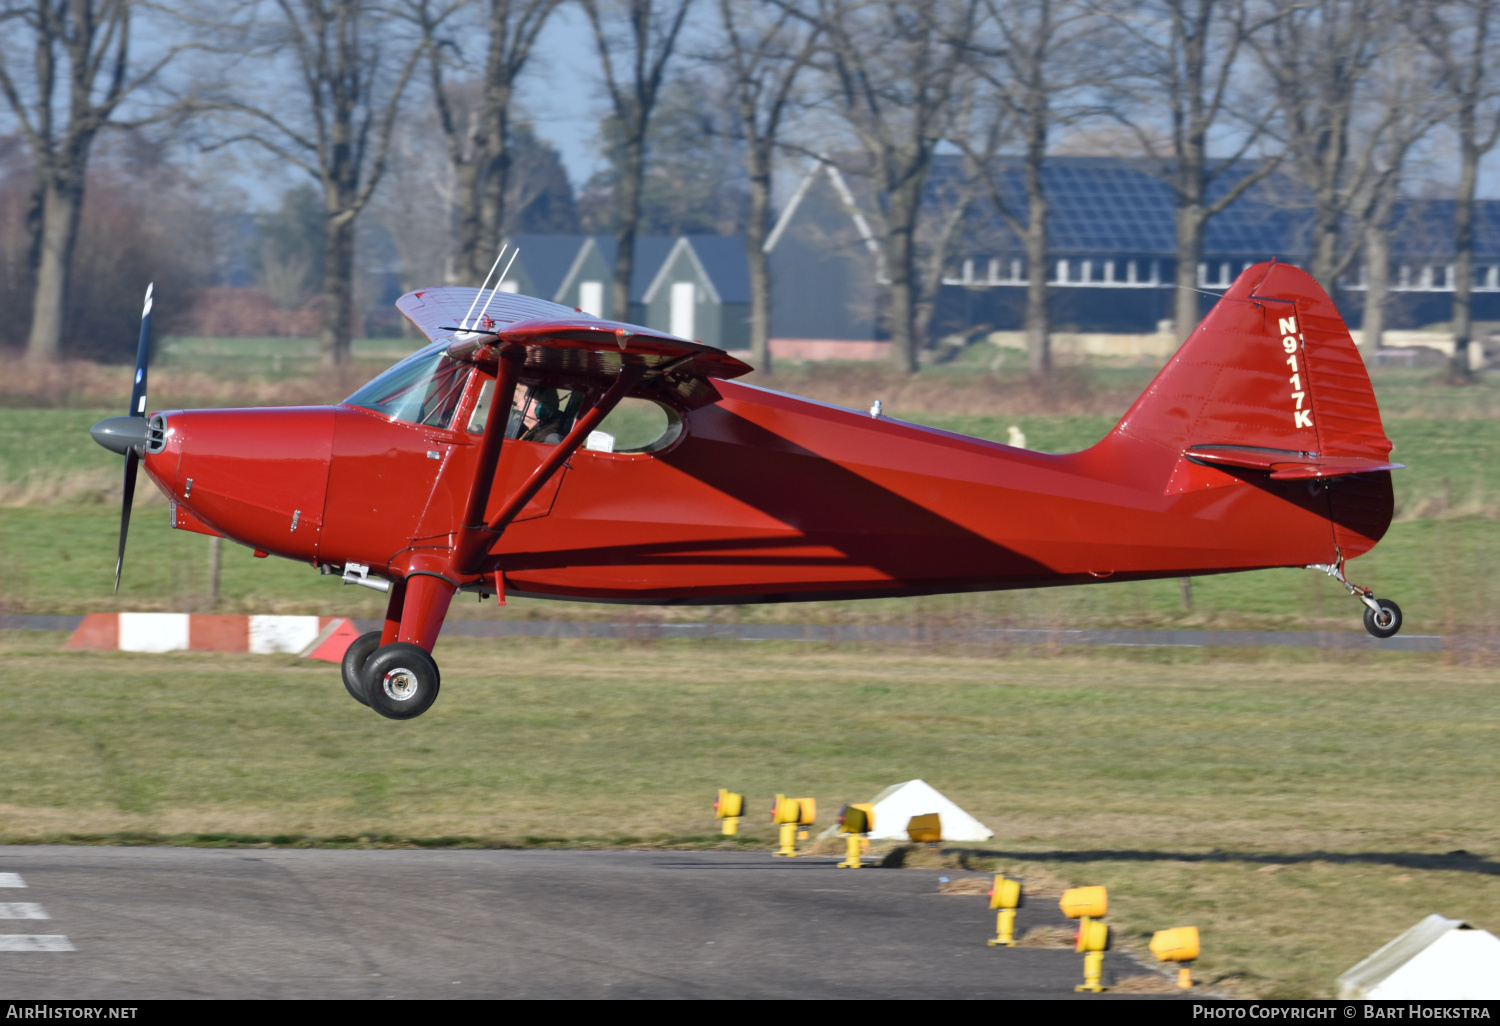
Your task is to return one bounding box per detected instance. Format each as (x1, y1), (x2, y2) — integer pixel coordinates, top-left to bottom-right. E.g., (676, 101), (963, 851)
(0, 632), (1500, 996)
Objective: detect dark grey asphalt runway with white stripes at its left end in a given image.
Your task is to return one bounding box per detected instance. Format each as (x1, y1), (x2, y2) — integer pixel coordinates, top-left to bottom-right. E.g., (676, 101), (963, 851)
(0, 846), (1142, 1001)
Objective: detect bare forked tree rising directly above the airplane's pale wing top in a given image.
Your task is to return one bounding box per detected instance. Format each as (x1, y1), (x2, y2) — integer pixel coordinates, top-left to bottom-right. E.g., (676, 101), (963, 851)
(414, 0), (561, 284)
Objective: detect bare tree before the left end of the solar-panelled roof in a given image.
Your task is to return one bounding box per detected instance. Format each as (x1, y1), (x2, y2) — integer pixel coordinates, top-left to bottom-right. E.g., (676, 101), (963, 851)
(957, 0), (1098, 374)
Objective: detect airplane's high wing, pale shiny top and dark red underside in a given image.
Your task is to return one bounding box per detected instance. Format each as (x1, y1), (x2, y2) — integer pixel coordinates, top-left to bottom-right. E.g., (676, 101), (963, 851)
(396, 287), (752, 410)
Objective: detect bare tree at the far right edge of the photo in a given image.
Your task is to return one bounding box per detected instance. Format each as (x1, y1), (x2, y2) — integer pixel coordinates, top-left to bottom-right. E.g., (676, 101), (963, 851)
(1409, 0), (1500, 377)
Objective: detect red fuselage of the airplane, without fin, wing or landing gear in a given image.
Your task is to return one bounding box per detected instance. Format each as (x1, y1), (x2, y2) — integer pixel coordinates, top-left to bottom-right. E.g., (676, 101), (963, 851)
(146, 372), (1389, 603)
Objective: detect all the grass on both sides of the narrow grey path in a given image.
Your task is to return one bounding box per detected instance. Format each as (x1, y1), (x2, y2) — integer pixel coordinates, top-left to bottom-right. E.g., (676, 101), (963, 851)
(0, 351), (1500, 996)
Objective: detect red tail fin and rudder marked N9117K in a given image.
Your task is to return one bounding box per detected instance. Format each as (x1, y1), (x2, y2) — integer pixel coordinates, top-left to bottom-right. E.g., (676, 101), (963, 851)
(1112, 261), (1400, 557)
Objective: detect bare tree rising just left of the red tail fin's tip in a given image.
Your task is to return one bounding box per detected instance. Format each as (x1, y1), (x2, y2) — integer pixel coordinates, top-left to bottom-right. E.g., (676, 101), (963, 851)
(1101, 0), (1280, 342)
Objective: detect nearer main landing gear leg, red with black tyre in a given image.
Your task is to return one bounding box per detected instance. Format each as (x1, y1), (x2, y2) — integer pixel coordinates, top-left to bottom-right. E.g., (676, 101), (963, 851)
(364, 573), (456, 720)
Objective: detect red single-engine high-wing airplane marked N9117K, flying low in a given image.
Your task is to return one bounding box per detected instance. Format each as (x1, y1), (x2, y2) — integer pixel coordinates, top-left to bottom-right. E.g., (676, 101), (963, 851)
(92, 261), (1401, 720)
